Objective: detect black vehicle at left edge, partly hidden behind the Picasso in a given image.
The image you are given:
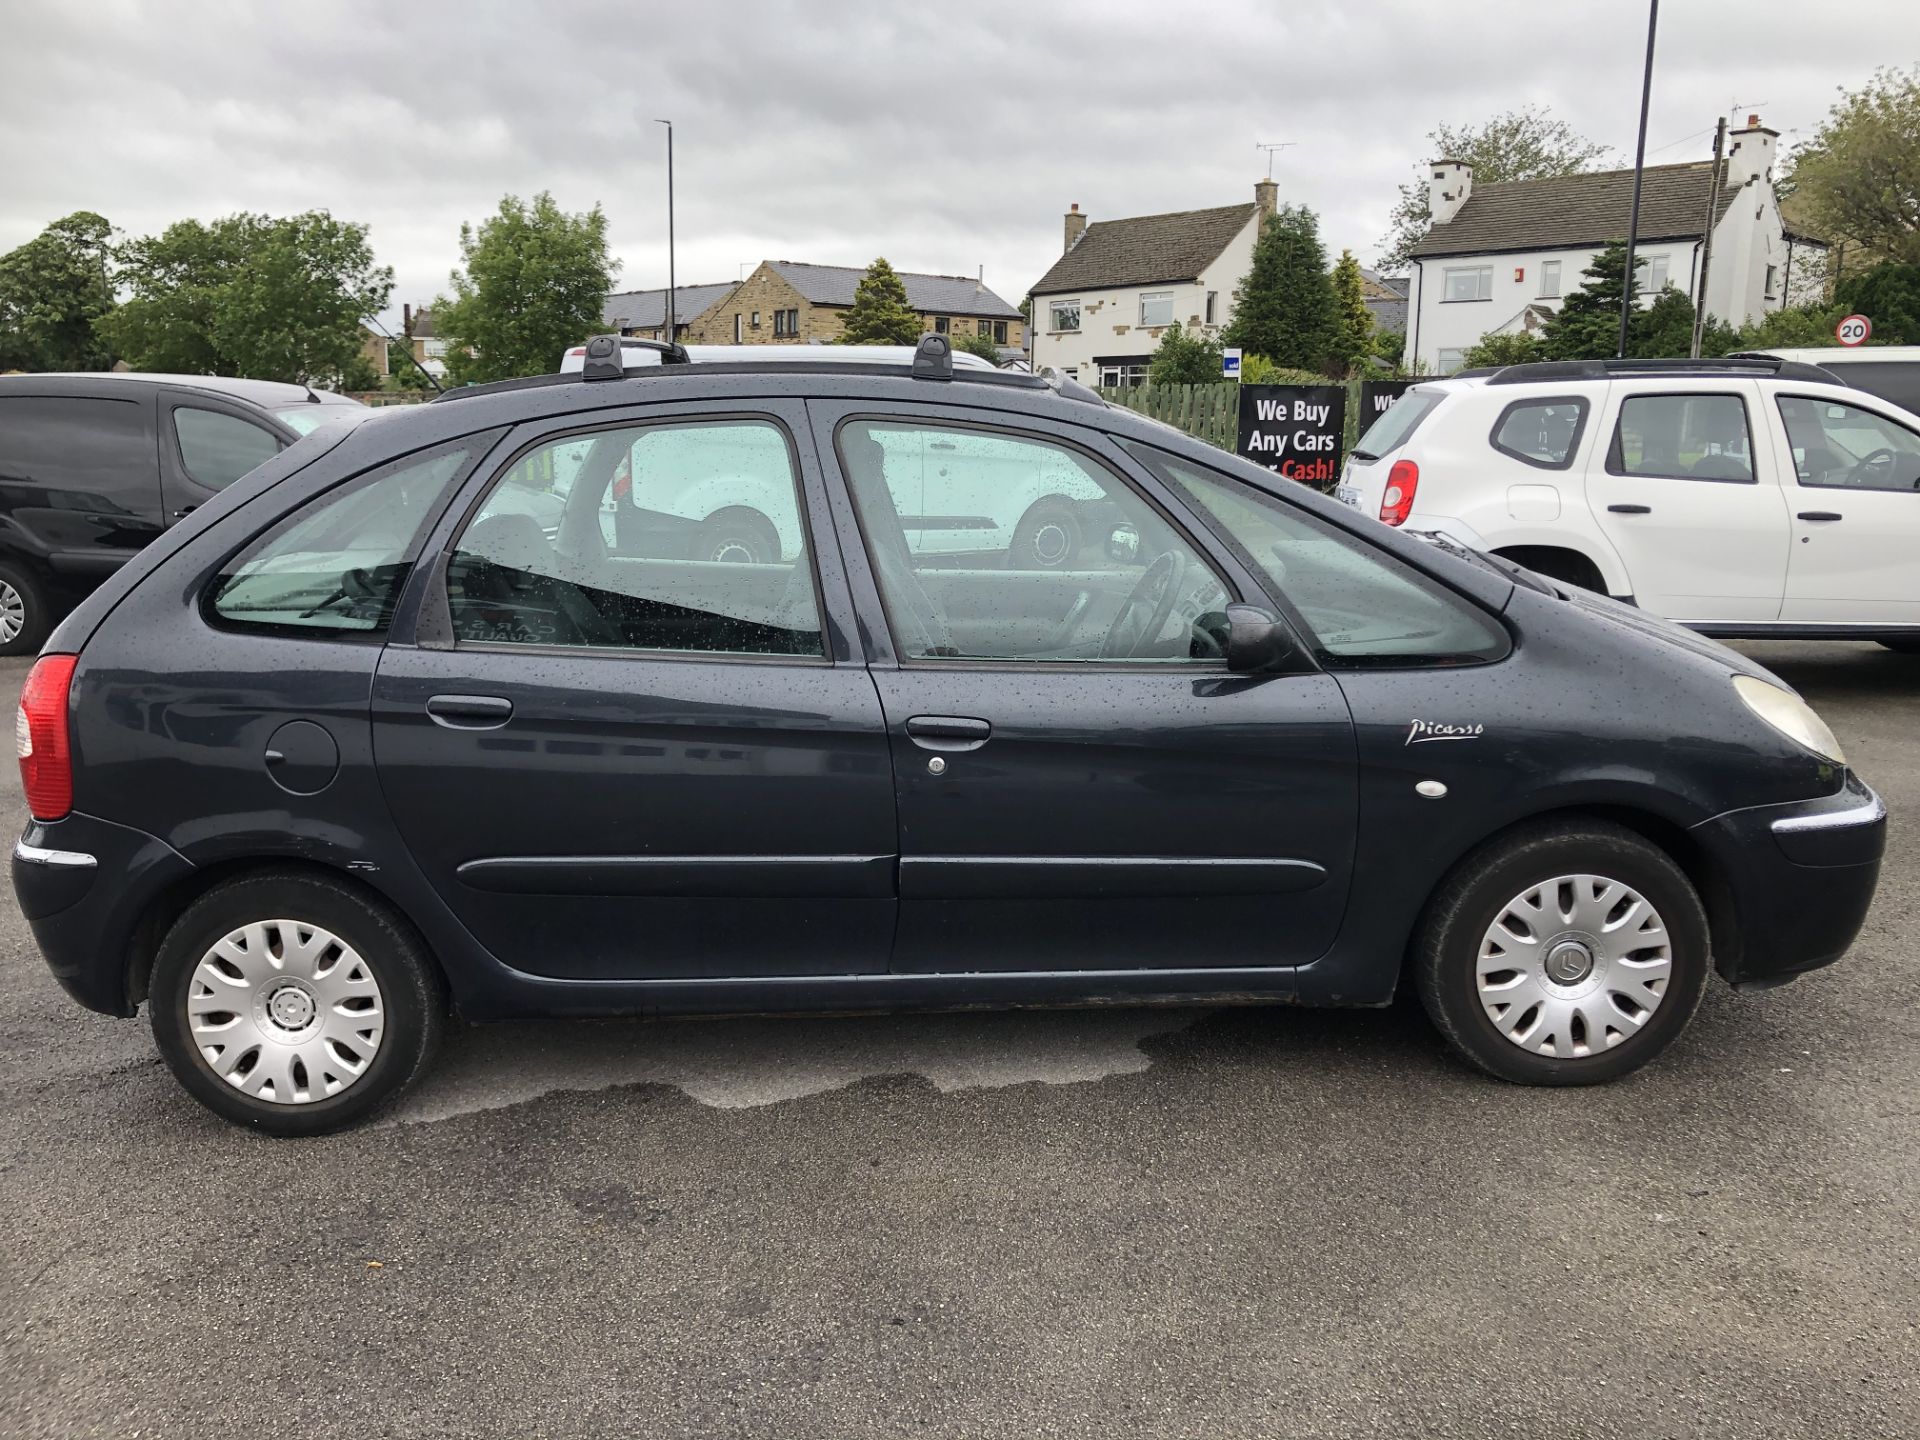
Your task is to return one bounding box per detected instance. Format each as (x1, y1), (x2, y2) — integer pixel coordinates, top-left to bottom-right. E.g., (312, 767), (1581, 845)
(0, 372), (374, 655)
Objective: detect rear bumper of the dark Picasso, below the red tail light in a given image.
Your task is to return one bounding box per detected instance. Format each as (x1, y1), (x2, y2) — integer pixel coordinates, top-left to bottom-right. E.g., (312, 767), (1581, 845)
(13, 814), (194, 1016)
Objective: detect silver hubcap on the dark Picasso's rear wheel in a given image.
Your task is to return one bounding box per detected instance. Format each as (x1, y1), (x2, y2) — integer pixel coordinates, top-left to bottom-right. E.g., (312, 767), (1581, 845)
(186, 920), (386, 1106)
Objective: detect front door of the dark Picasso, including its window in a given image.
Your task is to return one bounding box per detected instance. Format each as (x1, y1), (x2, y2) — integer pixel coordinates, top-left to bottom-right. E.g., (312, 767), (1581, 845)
(808, 401), (1357, 972)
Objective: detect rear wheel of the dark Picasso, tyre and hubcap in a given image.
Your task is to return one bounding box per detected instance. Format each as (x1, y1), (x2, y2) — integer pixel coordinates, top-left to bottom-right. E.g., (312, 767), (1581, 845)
(148, 872), (447, 1135)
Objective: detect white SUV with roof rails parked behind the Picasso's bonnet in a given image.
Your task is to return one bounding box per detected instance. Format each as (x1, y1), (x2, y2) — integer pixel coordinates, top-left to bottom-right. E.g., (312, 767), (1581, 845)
(1334, 359), (1920, 649)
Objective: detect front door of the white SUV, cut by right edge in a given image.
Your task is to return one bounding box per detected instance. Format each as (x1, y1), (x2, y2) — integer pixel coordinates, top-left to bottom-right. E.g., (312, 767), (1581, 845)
(1768, 394), (1920, 626)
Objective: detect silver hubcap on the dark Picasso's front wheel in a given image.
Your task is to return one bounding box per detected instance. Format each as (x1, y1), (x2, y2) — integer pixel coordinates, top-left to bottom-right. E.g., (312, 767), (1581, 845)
(1475, 876), (1672, 1060)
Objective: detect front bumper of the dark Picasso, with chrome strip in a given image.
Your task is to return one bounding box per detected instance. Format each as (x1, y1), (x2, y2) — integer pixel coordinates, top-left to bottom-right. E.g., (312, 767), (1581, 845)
(1692, 772), (1887, 989)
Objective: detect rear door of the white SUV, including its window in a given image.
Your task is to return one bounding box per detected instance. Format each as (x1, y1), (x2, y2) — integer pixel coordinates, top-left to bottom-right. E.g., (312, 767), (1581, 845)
(1586, 378), (1789, 620)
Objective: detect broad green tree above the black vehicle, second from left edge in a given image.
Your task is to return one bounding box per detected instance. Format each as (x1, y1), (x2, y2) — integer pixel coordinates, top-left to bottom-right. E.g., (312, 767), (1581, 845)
(100, 209), (394, 384)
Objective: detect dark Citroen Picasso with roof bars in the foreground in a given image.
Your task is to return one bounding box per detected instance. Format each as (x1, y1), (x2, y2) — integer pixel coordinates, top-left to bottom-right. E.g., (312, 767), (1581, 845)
(13, 336), (1885, 1133)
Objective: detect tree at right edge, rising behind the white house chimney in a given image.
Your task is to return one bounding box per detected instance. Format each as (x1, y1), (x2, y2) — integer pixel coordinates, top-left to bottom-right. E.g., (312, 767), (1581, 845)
(1782, 65), (1920, 266)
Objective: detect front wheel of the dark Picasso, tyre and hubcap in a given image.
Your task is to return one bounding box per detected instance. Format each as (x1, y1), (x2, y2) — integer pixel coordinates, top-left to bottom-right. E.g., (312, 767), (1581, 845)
(1413, 820), (1711, 1085)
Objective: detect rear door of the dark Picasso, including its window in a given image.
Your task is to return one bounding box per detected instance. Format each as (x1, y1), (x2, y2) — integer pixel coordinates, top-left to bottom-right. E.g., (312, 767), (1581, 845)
(372, 403), (895, 979)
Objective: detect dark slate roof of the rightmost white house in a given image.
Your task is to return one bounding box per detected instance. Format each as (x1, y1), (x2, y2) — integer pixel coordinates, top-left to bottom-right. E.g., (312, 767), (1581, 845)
(1411, 159), (1740, 259)
